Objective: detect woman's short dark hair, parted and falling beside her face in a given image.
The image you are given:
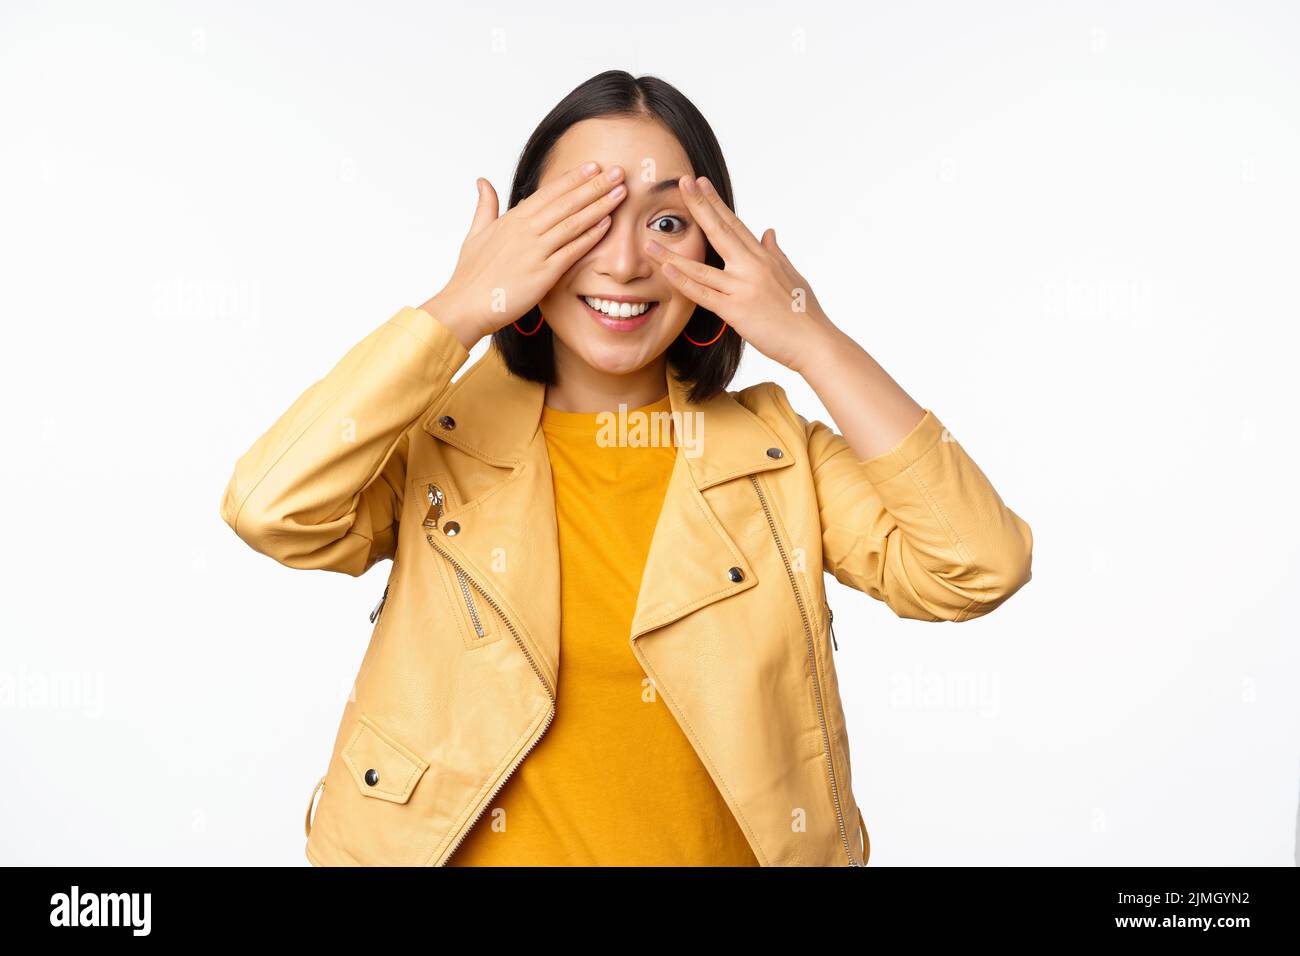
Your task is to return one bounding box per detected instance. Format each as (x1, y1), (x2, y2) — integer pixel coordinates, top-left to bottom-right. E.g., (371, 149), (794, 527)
(493, 70), (745, 402)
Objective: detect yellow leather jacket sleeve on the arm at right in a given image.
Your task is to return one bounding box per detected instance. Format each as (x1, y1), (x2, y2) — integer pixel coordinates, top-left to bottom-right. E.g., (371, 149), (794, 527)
(787, 387), (1034, 622)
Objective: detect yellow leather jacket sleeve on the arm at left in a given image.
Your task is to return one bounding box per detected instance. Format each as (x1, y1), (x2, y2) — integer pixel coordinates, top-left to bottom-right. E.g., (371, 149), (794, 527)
(221, 307), (469, 576)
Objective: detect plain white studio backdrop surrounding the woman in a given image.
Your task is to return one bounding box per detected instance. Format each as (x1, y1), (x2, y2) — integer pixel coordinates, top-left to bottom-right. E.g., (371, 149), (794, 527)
(0, 0), (1300, 866)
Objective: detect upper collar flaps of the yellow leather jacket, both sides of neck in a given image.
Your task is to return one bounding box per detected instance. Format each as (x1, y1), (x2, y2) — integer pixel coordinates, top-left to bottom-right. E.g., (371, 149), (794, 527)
(424, 343), (793, 490)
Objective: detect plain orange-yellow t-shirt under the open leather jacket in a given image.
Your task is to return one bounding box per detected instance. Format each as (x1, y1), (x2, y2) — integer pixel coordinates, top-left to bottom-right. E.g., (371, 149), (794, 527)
(447, 395), (758, 866)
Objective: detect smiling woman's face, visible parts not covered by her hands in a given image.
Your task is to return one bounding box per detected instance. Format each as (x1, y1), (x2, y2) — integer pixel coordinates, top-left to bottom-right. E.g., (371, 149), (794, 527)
(538, 117), (706, 375)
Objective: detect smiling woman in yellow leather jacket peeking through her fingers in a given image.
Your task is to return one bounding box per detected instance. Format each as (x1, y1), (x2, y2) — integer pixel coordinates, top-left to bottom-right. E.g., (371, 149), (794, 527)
(221, 72), (1032, 866)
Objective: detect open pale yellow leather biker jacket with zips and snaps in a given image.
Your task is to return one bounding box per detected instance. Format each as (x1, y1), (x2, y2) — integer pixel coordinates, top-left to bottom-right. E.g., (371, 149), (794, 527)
(221, 308), (1032, 866)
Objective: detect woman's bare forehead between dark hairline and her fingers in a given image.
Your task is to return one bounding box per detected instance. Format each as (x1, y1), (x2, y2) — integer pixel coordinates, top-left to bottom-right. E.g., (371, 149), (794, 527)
(541, 116), (696, 189)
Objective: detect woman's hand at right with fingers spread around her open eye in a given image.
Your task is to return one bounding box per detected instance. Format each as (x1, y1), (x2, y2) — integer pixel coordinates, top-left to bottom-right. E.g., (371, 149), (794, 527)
(646, 176), (836, 372)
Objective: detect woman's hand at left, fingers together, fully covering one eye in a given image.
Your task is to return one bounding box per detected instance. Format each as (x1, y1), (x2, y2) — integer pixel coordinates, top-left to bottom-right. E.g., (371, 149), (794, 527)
(423, 163), (628, 349)
